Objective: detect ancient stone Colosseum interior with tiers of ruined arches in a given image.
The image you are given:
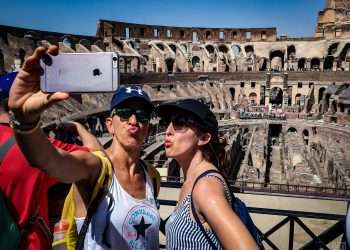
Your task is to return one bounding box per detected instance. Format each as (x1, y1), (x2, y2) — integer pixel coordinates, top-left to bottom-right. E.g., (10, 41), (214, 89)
(0, 0), (350, 188)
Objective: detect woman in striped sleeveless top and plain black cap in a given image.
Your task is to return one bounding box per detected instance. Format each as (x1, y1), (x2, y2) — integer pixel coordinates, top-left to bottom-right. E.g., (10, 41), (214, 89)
(156, 99), (258, 249)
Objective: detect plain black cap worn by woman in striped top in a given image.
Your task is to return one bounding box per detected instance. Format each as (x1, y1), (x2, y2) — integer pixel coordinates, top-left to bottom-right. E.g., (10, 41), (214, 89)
(156, 99), (219, 138)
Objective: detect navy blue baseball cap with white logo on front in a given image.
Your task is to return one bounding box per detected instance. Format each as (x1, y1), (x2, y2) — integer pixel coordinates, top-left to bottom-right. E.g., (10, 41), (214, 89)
(110, 85), (154, 112)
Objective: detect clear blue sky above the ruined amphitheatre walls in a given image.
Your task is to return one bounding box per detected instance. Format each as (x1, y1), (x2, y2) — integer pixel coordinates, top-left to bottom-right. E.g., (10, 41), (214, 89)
(0, 0), (326, 37)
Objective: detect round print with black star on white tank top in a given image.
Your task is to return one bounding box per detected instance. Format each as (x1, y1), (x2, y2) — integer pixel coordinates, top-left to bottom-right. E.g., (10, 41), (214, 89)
(123, 205), (158, 250)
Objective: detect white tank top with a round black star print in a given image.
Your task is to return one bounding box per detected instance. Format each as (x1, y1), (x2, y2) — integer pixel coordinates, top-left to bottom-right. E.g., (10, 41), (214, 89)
(80, 166), (160, 250)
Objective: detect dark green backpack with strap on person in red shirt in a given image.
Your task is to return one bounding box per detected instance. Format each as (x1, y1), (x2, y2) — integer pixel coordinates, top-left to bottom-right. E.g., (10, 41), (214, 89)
(0, 137), (21, 250)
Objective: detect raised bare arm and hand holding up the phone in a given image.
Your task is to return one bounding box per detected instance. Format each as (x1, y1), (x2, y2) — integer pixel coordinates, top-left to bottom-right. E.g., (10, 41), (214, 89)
(9, 46), (101, 183)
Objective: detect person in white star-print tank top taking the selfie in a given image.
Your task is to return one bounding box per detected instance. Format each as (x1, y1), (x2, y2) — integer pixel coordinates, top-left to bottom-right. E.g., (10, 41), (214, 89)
(9, 46), (160, 249)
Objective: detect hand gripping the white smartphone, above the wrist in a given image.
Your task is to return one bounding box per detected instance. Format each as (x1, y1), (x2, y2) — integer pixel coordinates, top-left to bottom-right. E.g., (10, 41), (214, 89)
(9, 46), (69, 123)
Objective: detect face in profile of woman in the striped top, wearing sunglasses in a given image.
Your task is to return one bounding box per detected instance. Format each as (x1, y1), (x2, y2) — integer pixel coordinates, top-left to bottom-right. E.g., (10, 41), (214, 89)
(162, 113), (202, 161)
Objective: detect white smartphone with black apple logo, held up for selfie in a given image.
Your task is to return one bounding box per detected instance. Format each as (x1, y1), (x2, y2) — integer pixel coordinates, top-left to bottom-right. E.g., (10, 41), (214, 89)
(40, 52), (119, 93)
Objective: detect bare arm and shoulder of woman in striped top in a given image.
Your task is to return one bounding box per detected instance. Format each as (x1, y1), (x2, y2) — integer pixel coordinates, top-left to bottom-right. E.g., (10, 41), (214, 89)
(193, 178), (258, 250)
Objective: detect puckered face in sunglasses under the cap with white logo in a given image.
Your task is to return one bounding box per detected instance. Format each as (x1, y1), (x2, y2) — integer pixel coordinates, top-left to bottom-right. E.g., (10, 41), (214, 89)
(106, 99), (150, 150)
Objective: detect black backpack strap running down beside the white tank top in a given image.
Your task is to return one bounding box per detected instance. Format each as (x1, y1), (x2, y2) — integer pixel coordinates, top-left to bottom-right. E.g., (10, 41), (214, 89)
(75, 174), (109, 250)
